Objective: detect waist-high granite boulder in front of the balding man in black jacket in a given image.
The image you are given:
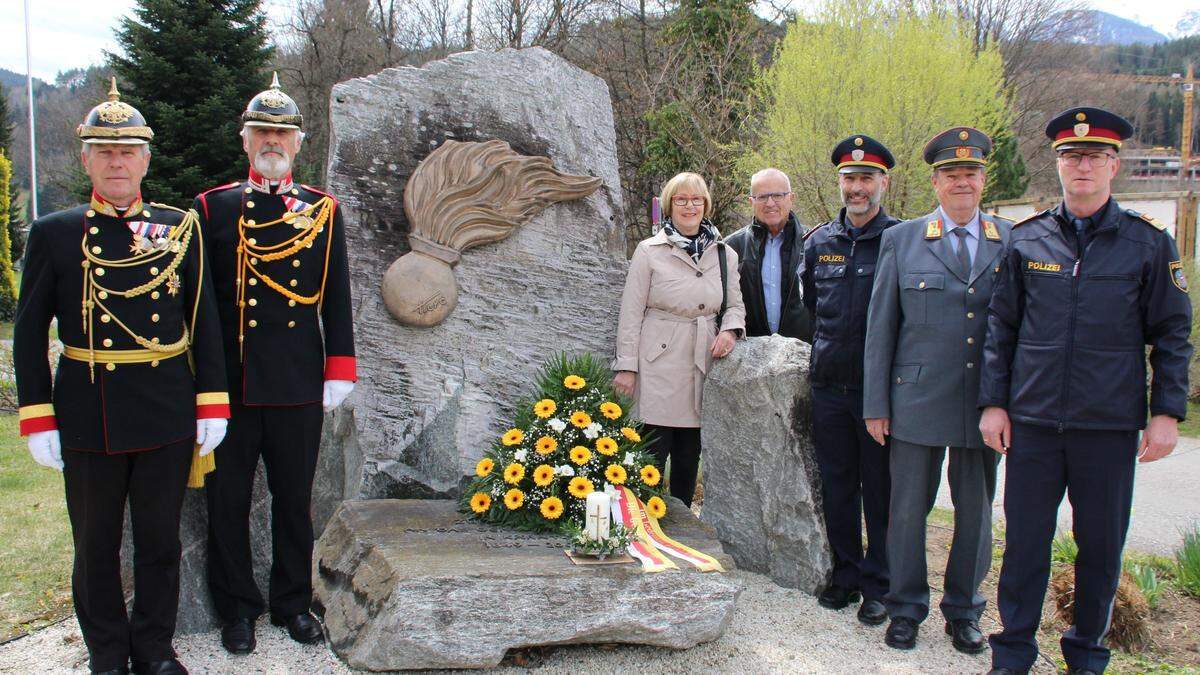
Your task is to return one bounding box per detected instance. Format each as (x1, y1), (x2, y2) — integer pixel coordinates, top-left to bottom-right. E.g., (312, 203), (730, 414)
(701, 335), (833, 593)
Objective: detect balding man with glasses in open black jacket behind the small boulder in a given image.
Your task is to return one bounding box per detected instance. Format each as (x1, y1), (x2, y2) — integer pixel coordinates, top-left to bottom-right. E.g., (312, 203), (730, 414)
(725, 168), (812, 342)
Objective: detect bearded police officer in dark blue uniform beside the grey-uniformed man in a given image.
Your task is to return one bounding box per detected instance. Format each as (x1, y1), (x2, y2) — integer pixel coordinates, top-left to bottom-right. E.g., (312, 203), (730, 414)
(797, 135), (900, 626)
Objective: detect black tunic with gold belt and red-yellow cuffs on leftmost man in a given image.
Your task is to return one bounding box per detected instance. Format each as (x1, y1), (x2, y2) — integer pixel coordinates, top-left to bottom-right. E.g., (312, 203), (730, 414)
(13, 197), (229, 454)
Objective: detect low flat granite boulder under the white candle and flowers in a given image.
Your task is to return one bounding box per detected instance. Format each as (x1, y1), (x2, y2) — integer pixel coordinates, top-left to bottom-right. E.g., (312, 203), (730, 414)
(313, 500), (742, 670)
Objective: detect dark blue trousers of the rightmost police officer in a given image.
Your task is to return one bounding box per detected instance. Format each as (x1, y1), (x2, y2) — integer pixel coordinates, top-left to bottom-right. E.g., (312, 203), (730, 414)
(989, 423), (1138, 673)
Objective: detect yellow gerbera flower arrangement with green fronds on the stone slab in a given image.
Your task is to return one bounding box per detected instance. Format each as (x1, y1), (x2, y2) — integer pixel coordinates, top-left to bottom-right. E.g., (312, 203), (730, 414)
(462, 353), (665, 533)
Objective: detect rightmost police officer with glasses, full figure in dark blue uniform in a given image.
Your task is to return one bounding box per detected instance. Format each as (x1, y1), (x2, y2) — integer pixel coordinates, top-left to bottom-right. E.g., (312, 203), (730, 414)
(979, 108), (1192, 674)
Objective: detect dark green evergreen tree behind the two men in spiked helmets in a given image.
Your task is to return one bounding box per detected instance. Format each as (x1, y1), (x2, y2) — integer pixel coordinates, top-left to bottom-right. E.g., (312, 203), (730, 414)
(108, 0), (272, 208)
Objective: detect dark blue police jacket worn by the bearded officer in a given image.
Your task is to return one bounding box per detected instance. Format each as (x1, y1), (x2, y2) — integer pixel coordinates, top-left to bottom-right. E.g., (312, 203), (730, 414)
(797, 208), (900, 389)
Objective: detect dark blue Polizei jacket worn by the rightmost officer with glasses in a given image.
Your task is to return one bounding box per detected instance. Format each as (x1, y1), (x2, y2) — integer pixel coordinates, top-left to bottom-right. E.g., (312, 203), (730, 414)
(979, 201), (1192, 430)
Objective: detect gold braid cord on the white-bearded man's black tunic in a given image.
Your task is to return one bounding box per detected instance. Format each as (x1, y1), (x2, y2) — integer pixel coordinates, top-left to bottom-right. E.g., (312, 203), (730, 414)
(238, 197), (334, 352)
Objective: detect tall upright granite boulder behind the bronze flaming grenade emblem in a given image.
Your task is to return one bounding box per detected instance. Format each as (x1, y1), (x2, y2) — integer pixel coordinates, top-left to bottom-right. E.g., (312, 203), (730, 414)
(328, 48), (626, 498)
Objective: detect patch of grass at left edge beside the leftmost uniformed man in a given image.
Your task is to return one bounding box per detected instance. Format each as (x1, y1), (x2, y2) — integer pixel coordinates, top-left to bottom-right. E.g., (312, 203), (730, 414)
(0, 414), (72, 640)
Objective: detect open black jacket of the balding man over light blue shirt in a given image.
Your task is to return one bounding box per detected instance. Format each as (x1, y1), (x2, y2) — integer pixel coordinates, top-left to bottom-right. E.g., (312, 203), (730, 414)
(725, 214), (812, 342)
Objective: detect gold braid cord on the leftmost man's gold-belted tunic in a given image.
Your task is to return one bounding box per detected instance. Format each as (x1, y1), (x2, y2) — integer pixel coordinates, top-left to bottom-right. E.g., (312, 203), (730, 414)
(79, 210), (197, 381)
